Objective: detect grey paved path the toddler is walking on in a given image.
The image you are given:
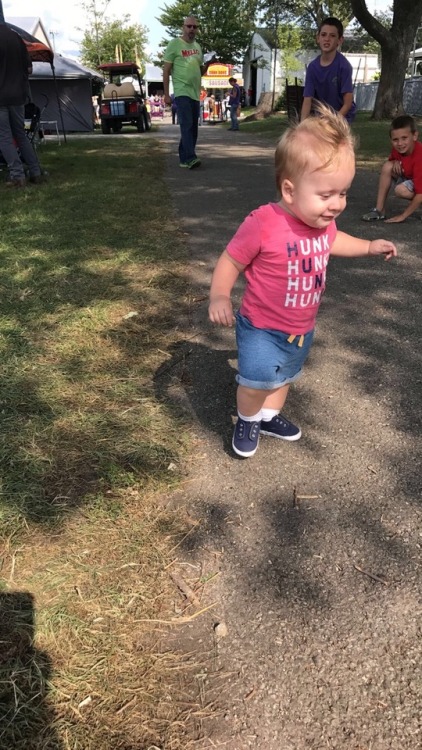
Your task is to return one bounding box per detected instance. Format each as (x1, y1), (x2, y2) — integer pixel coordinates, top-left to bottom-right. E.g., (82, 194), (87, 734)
(153, 124), (422, 750)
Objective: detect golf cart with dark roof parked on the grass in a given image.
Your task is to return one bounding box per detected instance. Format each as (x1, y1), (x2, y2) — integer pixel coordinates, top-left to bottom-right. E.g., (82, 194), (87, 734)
(99, 62), (151, 134)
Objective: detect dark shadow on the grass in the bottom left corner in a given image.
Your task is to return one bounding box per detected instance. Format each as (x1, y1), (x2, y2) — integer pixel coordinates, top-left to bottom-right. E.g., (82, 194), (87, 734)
(0, 592), (63, 750)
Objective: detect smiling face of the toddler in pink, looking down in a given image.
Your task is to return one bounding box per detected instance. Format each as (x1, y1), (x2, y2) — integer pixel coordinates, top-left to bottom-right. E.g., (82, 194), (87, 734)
(281, 151), (355, 229)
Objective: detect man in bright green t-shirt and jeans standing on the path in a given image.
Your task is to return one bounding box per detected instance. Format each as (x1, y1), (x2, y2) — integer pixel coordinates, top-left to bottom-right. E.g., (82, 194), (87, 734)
(163, 16), (211, 169)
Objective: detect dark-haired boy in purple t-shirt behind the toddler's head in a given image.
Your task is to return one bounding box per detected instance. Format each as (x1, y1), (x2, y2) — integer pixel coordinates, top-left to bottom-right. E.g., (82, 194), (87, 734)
(301, 18), (356, 123)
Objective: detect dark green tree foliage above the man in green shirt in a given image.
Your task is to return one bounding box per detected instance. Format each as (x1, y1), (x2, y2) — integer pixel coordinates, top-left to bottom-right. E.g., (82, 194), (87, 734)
(157, 0), (256, 64)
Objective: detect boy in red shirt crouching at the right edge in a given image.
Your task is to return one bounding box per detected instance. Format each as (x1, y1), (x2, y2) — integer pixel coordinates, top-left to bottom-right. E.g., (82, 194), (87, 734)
(362, 115), (422, 224)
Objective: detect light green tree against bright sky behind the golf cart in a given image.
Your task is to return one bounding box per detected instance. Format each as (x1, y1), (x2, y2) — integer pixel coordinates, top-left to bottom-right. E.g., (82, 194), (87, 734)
(81, 0), (148, 70)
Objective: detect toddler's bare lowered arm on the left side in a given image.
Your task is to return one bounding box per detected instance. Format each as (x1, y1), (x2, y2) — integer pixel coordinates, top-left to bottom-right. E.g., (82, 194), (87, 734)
(208, 250), (245, 326)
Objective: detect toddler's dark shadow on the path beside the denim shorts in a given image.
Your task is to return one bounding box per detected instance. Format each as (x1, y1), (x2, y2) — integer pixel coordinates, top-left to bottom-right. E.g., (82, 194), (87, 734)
(154, 341), (237, 451)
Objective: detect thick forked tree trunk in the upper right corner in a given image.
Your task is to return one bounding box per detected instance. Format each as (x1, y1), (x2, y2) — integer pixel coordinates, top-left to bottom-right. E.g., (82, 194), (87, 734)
(350, 0), (422, 120)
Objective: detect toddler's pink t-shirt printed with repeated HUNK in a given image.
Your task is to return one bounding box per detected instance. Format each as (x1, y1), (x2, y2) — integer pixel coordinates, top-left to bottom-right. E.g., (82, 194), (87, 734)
(227, 203), (337, 335)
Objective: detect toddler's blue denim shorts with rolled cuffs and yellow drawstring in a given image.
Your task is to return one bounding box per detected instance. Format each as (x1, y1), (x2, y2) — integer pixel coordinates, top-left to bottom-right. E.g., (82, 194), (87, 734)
(236, 312), (314, 391)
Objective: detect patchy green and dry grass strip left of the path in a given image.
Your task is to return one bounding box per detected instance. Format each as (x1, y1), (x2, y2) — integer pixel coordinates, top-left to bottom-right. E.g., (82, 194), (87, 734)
(0, 136), (209, 750)
